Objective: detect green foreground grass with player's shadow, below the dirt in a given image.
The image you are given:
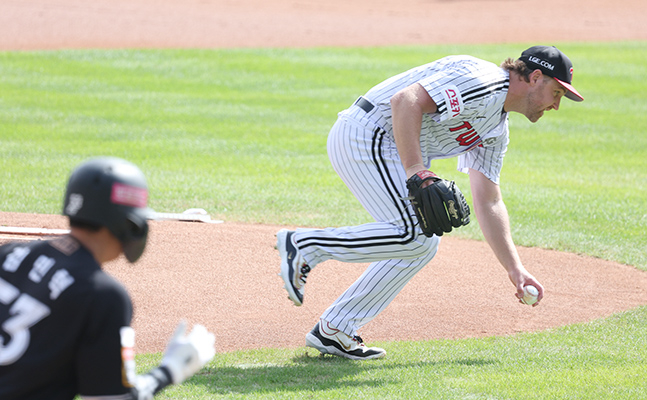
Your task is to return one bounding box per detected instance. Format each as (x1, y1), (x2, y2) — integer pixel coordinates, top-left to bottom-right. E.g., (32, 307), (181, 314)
(138, 307), (647, 400)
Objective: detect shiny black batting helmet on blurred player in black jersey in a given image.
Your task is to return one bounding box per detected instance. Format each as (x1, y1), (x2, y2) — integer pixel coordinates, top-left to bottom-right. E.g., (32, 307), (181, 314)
(63, 157), (150, 263)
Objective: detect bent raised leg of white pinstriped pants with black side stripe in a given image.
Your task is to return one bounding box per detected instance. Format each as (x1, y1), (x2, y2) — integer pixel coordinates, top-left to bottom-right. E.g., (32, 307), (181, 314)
(294, 118), (436, 265)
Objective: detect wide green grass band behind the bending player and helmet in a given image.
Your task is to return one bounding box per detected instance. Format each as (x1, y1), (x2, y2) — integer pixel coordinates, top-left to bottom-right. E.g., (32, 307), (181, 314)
(0, 43), (647, 269)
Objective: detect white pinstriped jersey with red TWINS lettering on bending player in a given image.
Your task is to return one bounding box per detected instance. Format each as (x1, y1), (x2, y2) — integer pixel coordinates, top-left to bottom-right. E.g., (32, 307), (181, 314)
(347, 56), (509, 183)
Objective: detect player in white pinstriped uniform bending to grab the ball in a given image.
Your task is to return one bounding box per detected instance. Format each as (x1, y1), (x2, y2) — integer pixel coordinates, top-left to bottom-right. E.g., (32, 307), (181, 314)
(277, 46), (583, 360)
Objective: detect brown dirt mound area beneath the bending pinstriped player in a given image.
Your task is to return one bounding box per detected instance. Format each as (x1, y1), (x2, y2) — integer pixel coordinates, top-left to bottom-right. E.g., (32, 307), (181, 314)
(2, 213), (647, 352)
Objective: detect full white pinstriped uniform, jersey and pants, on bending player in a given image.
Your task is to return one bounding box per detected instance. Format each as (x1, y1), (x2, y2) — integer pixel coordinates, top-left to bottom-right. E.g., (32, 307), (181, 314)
(293, 56), (520, 336)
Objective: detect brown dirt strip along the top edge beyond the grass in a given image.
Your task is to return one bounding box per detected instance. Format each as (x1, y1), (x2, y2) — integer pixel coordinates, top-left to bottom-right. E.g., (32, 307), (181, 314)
(0, 0), (647, 50)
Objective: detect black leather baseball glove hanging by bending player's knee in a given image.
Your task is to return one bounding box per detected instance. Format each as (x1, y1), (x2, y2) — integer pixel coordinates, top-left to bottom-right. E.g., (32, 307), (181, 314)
(407, 170), (470, 237)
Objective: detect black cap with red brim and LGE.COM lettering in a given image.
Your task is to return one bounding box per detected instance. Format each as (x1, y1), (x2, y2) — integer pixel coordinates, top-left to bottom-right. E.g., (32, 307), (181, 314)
(519, 46), (584, 101)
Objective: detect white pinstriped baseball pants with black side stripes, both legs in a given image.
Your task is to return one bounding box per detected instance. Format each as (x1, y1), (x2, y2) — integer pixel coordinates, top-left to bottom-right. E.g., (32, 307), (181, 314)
(294, 111), (440, 336)
